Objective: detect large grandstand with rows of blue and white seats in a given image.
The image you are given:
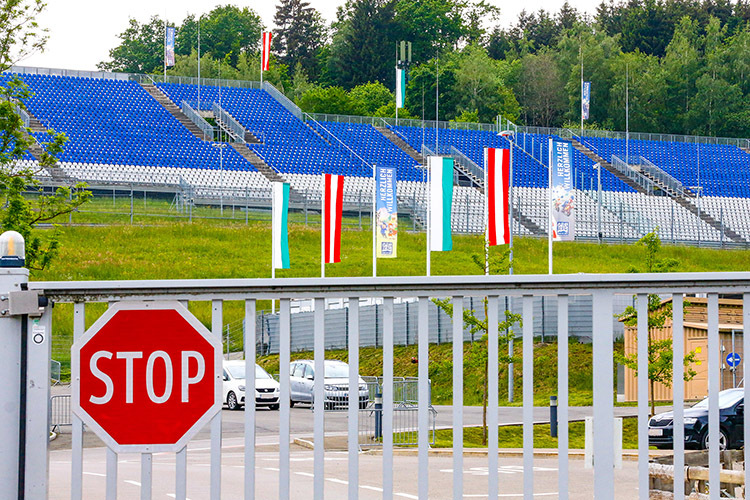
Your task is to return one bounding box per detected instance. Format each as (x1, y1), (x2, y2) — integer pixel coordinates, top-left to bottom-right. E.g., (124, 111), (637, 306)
(5, 67), (750, 246)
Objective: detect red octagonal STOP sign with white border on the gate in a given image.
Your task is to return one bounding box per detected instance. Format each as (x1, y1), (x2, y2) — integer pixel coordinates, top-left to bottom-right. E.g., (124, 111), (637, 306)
(71, 302), (222, 452)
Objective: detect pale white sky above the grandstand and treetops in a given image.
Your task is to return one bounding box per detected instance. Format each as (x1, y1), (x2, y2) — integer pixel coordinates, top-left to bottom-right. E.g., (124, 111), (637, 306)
(19, 0), (599, 71)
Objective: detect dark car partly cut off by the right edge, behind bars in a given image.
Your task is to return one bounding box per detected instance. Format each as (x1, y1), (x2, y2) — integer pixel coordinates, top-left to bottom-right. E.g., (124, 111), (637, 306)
(648, 389), (745, 450)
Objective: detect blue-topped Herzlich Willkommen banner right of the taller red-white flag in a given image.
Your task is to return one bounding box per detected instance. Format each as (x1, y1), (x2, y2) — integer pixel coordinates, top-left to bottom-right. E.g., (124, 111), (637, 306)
(549, 140), (576, 241)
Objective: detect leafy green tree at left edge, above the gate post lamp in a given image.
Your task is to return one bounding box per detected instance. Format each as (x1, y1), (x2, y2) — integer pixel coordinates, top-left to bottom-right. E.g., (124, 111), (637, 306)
(0, 0), (91, 270)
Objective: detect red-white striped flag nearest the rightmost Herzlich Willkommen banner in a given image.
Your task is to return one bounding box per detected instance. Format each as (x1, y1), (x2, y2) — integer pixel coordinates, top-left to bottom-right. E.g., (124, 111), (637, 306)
(484, 148), (510, 246)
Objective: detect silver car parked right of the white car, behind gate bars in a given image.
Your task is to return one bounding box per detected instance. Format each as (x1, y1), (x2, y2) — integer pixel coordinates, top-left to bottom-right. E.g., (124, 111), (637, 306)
(289, 359), (370, 410)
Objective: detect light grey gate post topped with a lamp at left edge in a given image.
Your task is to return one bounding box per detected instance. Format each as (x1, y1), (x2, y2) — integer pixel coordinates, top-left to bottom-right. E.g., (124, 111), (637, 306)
(0, 231), (51, 500)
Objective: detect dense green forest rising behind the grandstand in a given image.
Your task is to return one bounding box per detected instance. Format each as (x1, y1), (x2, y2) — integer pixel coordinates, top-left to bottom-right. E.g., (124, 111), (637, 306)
(99, 0), (750, 137)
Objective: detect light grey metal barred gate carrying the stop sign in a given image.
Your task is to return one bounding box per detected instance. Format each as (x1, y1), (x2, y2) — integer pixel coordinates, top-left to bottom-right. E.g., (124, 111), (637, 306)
(3, 273), (750, 500)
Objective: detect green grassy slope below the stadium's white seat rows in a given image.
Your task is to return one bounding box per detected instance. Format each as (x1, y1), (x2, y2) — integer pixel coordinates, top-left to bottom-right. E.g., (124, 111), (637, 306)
(31, 221), (750, 380)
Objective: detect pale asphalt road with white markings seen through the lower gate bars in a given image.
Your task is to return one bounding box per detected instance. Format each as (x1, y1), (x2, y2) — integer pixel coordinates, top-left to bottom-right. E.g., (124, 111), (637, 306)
(49, 437), (637, 500)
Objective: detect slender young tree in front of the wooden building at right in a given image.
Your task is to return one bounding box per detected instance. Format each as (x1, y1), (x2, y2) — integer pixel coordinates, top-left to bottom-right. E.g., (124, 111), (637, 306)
(615, 232), (698, 415)
